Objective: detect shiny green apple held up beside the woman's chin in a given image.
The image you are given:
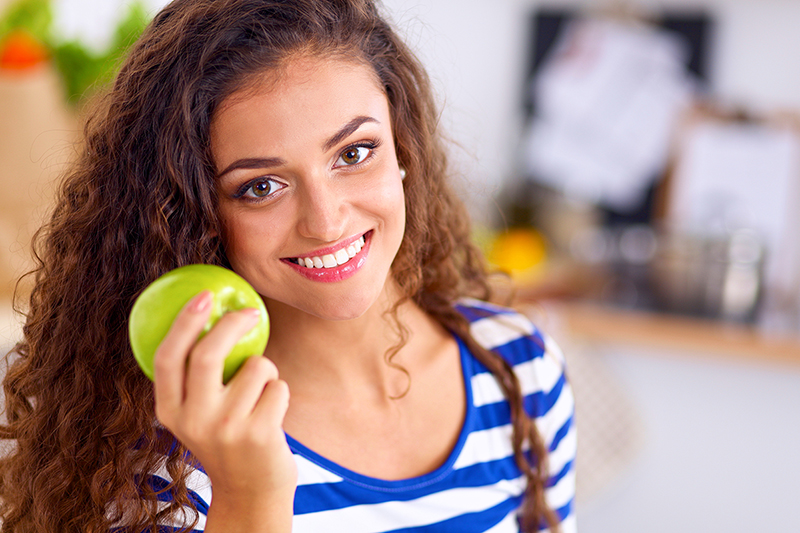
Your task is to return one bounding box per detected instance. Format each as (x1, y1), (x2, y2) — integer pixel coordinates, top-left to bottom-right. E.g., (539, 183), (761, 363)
(128, 265), (269, 383)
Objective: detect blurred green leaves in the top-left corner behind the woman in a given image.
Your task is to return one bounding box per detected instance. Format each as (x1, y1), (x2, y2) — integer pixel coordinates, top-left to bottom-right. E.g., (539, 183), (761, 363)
(0, 0), (150, 105)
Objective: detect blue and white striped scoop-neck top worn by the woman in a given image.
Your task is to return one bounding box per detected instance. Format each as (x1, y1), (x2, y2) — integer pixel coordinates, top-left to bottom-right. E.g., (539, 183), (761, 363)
(139, 300), (576, 533)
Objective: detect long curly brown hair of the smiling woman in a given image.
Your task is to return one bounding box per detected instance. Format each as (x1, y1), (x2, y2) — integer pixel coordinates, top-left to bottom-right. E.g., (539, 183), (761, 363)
(0, 0), (557, 533)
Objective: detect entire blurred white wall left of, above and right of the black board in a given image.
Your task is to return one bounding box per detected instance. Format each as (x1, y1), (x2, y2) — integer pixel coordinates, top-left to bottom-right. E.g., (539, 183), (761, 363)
(384, 0), (800, 222)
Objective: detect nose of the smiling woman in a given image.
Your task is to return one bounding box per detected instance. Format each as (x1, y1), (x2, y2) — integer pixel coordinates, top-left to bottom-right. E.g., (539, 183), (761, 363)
(297, 178), (347, 242)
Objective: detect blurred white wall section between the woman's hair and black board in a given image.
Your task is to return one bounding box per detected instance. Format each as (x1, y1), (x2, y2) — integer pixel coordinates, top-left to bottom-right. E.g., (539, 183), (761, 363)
(384, 0), (529, 222)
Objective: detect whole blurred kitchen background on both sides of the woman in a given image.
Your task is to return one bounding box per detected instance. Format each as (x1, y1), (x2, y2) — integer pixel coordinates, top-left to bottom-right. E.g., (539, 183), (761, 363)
(0, 0), (800, 533)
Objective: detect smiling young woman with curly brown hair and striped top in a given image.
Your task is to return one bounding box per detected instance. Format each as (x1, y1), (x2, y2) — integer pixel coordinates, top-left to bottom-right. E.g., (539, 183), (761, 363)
(0, 0), (575, 533)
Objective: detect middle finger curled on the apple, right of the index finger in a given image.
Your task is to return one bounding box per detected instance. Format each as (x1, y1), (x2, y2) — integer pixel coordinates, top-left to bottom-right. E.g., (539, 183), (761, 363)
(186, 309), (259, 406)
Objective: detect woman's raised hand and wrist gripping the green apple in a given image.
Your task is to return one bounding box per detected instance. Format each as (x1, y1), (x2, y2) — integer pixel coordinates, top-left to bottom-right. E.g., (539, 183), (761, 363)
(155, 291), (297, 532)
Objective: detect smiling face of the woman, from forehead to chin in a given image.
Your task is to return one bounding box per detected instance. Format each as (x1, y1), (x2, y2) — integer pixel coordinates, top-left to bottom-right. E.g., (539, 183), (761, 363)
(211, 58), (405, 320)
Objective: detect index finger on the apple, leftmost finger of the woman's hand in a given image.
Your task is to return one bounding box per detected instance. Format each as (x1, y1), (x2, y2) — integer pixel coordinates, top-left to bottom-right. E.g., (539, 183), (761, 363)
(153, 291), (213, 416)
